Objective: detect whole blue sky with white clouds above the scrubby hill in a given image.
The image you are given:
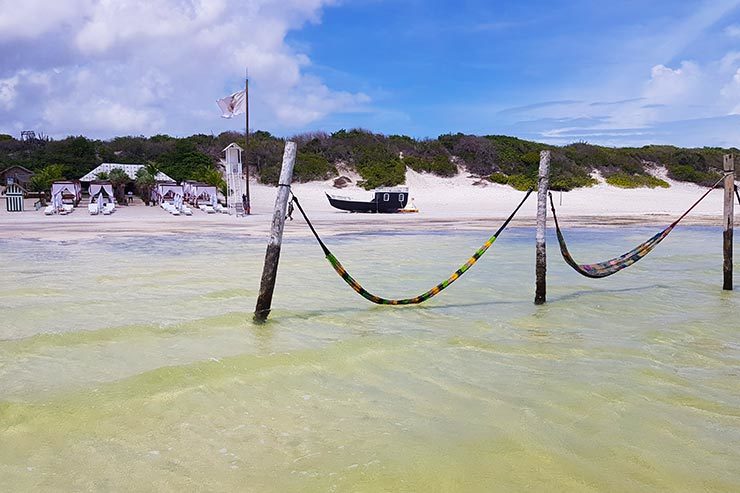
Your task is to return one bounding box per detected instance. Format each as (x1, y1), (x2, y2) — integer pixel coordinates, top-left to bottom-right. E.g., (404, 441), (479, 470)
(0, 0), (740, 147)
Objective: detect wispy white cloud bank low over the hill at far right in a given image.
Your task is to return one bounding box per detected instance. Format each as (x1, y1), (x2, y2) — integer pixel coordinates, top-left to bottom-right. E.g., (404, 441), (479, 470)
(499, 52), (740, 147)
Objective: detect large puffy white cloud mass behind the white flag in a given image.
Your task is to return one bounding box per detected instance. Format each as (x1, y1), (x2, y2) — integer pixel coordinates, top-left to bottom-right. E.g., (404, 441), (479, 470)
(0, 0), (369, 137)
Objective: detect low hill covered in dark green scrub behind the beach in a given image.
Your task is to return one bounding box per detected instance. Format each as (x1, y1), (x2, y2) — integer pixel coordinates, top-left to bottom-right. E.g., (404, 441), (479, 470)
(0, 129), (738, 190)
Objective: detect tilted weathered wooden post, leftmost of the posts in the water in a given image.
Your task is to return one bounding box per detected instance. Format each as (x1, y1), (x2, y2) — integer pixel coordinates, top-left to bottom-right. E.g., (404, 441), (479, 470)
(254, 141), (296, 322)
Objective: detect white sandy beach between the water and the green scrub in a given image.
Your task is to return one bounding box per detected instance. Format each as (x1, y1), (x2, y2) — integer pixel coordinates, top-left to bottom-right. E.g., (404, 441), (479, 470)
(0, 167), (740, 240)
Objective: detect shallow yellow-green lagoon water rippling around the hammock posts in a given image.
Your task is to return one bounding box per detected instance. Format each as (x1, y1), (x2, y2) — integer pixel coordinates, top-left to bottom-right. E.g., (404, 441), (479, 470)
(0, 227), (740, 492)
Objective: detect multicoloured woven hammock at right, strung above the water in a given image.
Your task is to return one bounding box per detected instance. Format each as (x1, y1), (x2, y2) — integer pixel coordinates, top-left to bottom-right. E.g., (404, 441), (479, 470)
(549, 177), (724, 279)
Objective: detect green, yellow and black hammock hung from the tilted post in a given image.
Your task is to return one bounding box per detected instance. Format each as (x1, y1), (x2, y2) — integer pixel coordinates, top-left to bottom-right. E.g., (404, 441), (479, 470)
(292, 189), (532, 305)
